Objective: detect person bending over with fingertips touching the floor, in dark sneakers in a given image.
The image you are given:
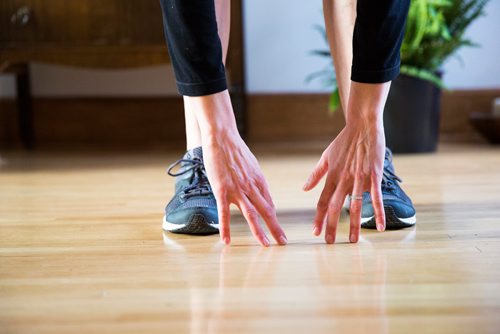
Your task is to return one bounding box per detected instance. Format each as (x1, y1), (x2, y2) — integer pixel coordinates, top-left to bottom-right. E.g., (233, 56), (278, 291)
(160, 0), (416, 246)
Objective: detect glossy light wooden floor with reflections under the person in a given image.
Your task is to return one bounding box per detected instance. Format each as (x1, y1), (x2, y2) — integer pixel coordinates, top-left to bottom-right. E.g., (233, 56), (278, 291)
(0, 146), (500, 334)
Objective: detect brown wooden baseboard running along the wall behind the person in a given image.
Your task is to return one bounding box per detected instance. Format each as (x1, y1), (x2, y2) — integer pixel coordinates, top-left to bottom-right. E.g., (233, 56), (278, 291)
(0, 89), (500, 149)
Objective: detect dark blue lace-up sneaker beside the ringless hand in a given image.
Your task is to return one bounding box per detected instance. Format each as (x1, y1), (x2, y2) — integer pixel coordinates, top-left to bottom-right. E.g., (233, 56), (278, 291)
(163, 147), (219, 235)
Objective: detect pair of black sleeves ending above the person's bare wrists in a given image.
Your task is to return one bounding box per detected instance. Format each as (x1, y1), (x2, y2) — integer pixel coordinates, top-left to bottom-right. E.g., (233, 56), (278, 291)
(160, 0), (410, 96)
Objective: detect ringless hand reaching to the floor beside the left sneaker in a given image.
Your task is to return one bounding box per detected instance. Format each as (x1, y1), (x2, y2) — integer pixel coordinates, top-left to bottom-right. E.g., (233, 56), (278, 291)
(195, 91), (287, 247)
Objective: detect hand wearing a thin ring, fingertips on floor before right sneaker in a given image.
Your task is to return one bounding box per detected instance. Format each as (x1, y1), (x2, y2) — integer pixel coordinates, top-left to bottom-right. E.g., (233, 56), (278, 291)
(304, 84), (390, 244)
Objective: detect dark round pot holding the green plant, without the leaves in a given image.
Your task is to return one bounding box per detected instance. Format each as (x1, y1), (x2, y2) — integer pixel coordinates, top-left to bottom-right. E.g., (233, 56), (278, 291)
(384, 74), (441, 153)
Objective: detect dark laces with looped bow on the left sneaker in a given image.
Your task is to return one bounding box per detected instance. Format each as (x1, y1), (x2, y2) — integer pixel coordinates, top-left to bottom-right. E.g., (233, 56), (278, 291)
(167, 158), (212, 198)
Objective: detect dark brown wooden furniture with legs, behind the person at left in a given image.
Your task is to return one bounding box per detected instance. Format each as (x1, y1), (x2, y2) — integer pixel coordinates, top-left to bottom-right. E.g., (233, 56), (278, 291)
(0, 0), (245, 148)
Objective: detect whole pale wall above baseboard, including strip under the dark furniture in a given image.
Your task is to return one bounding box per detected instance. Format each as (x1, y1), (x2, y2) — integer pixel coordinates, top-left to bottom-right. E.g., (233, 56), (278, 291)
(0, 0), (500, 97)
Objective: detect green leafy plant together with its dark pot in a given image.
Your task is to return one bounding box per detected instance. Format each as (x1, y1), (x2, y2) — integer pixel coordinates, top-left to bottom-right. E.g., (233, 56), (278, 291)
(309, 0), (488, 153)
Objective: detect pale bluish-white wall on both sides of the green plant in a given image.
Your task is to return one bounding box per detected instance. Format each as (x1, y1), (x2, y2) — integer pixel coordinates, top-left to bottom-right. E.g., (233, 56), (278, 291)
(245, 0), (500, 93)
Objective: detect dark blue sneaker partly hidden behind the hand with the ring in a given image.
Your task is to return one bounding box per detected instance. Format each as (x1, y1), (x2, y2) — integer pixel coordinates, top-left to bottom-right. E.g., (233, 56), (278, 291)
(344, 148), (417, 230)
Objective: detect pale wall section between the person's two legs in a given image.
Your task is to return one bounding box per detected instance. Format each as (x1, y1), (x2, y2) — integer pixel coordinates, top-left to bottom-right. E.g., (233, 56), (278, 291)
(244, 0), (329, 93)
